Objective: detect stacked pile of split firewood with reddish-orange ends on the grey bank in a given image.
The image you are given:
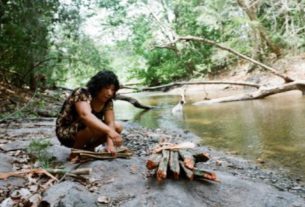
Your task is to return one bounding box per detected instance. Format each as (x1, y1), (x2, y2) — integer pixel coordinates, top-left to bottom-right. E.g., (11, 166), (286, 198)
(146, 144), (218, 181)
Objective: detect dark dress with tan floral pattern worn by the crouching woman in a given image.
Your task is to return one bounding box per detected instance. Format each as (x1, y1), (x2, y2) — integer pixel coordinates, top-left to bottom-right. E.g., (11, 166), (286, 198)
(56, 88), (113, 147)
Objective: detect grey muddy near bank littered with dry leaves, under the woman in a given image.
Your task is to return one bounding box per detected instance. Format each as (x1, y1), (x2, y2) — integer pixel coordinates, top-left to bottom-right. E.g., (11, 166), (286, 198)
(0, 119), (305, 207)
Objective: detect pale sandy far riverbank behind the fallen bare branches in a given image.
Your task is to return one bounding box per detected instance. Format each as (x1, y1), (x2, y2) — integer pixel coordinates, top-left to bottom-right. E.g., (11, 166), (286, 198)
(169, 53), (305, 101)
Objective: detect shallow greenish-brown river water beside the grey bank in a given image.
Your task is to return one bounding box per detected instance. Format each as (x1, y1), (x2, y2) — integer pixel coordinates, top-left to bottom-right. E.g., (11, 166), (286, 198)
(115, 92), (305, 180)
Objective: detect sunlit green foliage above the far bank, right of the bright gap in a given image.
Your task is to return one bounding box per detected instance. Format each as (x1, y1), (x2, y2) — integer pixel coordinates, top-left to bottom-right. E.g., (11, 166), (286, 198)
(94, 0), (305, 85)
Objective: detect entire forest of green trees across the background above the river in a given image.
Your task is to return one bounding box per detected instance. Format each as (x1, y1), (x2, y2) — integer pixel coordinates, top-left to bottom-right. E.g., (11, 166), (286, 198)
(0, 0), (305, 90)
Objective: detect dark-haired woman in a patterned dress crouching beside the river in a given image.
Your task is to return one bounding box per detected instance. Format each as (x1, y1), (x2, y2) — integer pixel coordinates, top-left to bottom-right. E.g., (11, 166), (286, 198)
(56, 70), (122, 162)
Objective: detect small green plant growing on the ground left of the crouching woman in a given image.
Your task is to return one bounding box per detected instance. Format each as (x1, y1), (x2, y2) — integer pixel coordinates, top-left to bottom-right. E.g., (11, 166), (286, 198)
(27, 139), (52, 168)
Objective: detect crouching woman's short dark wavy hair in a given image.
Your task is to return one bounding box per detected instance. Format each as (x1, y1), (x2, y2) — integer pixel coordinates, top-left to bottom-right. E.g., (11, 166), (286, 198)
(87, 70), (120, 97)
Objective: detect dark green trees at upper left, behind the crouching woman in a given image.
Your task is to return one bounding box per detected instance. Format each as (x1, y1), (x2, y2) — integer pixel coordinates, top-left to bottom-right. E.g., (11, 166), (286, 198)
(0, 0), (108, 90)
